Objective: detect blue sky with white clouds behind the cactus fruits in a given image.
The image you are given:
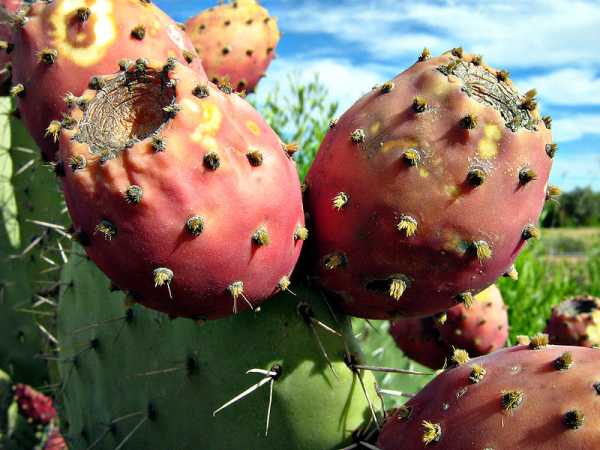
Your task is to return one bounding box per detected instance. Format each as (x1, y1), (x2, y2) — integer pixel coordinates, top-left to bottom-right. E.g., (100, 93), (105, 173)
(156, 0), (600, 190)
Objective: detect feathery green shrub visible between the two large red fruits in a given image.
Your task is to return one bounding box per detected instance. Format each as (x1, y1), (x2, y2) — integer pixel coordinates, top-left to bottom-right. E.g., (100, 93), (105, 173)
(254, 74), (338, 179)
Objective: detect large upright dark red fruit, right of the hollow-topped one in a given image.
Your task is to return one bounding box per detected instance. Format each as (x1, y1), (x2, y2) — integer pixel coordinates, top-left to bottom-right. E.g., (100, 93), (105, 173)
(306, 51), (555, 319)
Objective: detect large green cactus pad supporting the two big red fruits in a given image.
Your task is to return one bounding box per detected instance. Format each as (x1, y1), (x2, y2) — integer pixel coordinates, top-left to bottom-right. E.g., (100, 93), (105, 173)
(58, 248), (377, 450)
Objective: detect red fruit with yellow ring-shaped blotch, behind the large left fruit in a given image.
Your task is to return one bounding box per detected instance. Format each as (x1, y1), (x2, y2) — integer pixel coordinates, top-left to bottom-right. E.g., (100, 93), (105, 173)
(5, 0), (204, 161)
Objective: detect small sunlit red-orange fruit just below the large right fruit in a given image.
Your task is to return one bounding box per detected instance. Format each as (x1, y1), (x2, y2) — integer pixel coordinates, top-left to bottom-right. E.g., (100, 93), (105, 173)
(438, 285), (508, 356)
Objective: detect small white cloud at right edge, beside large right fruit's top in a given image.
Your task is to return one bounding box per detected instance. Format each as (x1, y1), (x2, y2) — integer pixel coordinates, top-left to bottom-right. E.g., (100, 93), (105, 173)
(517, 69), (600, 105)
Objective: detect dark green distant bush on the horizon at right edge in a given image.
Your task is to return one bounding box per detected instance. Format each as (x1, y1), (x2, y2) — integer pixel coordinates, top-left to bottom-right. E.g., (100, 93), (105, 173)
(542, 187), (600, 227)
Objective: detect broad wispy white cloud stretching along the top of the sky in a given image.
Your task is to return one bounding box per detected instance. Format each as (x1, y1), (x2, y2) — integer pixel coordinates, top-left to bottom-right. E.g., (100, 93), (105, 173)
(272, 0), (600, 67)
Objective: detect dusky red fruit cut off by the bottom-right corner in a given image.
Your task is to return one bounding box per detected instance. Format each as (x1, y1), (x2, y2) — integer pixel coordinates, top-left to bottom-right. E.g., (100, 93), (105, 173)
(377, 346), (600, 450)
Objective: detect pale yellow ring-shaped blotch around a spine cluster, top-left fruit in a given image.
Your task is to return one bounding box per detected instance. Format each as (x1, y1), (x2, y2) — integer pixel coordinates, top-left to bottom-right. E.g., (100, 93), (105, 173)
(48, 0), (117, 67)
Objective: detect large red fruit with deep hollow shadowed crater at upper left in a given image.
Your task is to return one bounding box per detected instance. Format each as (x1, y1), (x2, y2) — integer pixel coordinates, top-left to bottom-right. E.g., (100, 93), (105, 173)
(60, 60), (306, 320)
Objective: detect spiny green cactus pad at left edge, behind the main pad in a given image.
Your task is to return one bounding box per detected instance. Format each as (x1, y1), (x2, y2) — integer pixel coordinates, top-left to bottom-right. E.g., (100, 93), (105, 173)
(0, 98), (68, 386)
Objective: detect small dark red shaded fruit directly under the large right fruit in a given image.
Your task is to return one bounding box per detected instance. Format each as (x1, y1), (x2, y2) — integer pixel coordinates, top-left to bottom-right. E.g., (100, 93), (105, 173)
(390, 317), (448, 369)
